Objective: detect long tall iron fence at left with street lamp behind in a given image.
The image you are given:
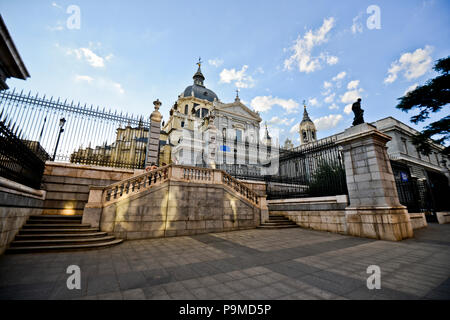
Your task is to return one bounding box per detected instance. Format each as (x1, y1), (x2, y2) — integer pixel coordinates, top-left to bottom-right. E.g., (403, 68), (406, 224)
(0, 90), (150, 168)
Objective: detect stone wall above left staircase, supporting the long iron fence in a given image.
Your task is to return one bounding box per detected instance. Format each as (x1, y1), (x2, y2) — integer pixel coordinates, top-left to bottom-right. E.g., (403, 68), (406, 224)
(42, 161), (143, 215)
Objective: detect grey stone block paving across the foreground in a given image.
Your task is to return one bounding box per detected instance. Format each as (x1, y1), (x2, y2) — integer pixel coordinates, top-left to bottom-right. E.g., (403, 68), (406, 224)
(0, 224), (450, 300)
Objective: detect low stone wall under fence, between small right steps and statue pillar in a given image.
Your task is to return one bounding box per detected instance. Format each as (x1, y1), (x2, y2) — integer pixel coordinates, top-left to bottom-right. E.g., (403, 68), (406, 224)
(267, 195), (348, 234)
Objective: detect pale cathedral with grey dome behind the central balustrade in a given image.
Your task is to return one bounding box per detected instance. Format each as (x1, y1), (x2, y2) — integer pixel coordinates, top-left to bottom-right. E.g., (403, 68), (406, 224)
(159, 62), (271, 169)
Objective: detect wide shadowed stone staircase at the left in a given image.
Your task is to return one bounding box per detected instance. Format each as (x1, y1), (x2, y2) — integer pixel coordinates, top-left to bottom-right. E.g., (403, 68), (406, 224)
(6, 215), (123, 253)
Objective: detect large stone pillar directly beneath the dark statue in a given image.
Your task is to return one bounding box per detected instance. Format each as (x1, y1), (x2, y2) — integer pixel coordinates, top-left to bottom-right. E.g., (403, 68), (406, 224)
(337, 123), (413, 241)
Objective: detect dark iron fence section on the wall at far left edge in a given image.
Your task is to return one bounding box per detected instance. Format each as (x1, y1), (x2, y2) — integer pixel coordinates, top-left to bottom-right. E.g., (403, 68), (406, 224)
(0, 110), (49, 189)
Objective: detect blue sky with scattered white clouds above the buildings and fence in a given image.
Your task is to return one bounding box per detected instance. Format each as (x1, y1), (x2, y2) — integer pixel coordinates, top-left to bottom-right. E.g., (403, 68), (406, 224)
(0, 0), (450, 145)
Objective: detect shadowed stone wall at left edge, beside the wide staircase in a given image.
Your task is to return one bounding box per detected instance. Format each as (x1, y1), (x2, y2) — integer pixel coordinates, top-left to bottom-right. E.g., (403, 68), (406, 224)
(0, 177), (45, 254)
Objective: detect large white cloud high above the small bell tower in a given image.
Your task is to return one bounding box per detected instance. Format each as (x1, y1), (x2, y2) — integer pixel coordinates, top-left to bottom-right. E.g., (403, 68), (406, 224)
(284, 17), (338, 73)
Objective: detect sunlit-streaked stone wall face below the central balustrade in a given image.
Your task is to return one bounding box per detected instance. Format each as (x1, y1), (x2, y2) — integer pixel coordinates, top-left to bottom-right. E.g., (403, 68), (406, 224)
(98, 180), (260, 239)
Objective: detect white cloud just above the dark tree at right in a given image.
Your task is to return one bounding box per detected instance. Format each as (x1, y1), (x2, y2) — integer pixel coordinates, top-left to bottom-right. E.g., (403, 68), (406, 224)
(384, 45), (433, 83)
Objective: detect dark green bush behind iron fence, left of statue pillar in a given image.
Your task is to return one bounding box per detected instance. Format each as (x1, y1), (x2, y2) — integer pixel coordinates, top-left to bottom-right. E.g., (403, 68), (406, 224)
(308, 161), (347, 196)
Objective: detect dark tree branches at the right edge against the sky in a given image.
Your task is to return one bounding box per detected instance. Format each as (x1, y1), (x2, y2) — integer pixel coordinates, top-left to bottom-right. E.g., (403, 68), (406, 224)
(396, 56), (450, 155)
